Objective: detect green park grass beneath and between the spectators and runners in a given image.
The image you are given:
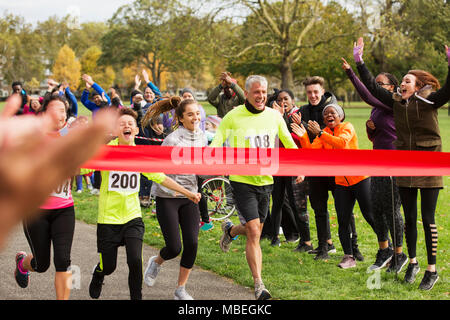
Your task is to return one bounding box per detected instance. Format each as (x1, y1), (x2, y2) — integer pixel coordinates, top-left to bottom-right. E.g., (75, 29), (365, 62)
(0, 99), (450, 300)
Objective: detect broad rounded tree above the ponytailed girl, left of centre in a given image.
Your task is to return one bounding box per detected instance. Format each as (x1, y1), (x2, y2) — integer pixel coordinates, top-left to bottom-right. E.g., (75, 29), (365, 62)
(100, 0), (216, 86)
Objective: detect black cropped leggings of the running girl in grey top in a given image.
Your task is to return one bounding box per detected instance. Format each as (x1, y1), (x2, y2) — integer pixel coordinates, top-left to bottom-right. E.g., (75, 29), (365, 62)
(156, 197), (200, 269)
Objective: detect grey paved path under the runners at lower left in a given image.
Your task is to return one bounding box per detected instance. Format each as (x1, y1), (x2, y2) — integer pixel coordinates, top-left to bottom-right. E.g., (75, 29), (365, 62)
(0, 221), (254, 300)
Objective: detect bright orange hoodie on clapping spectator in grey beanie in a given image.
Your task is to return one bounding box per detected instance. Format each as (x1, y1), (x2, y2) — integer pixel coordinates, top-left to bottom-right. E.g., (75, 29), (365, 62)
(292, 122), (368, 187)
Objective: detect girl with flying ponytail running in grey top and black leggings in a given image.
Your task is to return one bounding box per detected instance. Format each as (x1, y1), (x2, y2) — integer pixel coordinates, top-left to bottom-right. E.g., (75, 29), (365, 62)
(143, 97), (208, 300)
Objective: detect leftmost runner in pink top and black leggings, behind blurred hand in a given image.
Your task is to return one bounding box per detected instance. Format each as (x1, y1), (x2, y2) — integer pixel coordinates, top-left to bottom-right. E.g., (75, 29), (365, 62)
(14, 95), (75, 300)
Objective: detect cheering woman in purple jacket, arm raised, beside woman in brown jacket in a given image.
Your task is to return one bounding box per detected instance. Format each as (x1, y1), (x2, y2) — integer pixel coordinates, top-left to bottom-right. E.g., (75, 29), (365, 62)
(342, 58), (408, 273)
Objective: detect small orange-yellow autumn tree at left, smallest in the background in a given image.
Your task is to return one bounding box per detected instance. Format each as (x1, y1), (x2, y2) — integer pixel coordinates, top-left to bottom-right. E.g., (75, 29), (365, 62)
(53, 45), (81, 88)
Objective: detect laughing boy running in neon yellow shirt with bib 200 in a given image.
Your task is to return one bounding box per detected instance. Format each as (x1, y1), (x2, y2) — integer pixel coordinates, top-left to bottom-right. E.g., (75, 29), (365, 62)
(89, 108), (201, 300)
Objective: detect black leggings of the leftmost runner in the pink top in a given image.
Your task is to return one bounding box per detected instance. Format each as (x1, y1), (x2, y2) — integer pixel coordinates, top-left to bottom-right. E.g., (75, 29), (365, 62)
(23, 206), (75, 273)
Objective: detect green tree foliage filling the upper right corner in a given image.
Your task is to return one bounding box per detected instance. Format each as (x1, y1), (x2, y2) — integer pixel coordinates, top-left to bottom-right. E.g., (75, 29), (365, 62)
(352, 0), (450, 80)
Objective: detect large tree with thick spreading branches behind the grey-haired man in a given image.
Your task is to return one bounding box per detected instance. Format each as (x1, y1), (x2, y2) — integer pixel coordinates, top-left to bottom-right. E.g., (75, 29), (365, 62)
(216, 0), (355, 89)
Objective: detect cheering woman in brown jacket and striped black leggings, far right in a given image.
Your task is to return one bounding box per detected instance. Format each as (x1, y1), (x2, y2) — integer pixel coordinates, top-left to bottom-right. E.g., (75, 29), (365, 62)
(354, 38), (450, 290)
